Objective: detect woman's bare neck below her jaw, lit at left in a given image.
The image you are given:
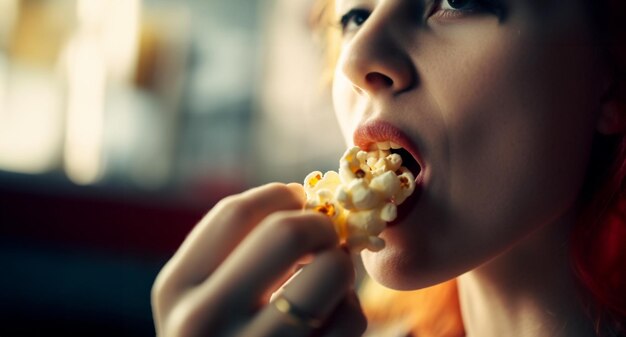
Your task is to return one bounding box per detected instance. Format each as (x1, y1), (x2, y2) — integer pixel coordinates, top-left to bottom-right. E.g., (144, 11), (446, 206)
(458, 210), (595, 337)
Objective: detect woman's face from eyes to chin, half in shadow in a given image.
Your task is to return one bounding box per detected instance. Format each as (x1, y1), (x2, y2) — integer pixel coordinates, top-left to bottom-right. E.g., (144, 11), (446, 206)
(333, 0), (606, 289)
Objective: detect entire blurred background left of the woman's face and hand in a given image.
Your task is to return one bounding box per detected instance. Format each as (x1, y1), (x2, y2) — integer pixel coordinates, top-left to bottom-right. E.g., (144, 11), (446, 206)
(0, 0), (344, 336)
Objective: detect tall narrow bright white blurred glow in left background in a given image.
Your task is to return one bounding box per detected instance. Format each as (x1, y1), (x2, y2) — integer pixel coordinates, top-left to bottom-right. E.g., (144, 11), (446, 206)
(65, 0), (140, 184)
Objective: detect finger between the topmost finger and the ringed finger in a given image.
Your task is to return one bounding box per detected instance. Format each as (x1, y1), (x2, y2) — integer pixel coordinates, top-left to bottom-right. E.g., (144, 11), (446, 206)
(191, 211), (338, 309)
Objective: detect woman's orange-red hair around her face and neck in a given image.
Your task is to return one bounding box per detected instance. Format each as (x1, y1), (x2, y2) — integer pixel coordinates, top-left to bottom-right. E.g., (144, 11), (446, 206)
(311, 0), (626, 337)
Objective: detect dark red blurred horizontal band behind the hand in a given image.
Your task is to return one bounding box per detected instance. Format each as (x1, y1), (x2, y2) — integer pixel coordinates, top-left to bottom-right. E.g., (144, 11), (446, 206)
(0, 172), (241, 256)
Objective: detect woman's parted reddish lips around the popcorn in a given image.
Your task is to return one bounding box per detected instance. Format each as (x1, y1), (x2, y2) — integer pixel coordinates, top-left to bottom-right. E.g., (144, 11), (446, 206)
(353, 121), (426, 226)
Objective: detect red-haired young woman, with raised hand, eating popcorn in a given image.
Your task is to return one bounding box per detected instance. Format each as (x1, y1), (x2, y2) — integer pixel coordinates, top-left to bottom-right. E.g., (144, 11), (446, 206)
(153, 0), (626, 337)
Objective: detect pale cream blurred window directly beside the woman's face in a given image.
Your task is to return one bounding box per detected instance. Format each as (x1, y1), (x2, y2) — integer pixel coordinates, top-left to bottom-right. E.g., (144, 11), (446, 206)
(253, 0), (345, 182)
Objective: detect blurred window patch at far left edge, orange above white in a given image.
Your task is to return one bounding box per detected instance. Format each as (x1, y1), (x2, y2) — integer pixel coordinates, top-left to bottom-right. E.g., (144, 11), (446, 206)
(0, 0), (72, 173)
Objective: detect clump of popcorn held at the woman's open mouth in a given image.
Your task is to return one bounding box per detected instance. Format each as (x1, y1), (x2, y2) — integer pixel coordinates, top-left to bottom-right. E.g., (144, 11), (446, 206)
(304, 146), (415, 252)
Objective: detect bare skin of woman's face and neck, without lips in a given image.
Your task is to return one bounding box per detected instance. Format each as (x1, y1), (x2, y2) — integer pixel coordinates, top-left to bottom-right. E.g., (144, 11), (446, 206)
(333, 0), (609, 336)
